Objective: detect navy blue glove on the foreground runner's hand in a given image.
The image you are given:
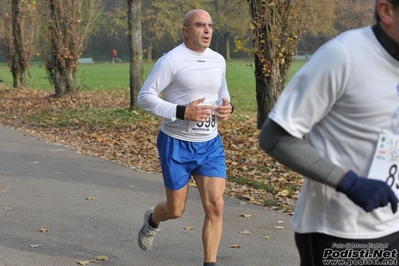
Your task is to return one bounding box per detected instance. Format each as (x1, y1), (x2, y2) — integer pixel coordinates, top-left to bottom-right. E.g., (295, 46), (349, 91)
(336, 170), (398, 213)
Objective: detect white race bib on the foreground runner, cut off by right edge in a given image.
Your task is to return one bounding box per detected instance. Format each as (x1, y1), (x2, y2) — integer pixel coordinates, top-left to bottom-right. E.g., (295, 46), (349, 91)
(368, 134), (399, 197)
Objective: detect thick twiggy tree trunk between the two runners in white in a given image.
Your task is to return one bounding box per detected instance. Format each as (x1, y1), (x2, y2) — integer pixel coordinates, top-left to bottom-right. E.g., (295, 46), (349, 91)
(247, 0), (303, 129)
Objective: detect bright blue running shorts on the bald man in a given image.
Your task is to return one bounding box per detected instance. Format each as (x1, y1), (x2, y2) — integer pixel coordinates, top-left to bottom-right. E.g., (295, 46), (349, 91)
(157, 130), (226, 190)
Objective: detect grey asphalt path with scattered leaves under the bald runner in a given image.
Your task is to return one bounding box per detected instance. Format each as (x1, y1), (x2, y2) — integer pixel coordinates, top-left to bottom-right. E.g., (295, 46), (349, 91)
(0, 126), (299, 266)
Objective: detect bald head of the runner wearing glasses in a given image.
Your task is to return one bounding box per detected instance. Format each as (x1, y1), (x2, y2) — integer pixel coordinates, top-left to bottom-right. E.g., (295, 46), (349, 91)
(183, 11), (213, 53)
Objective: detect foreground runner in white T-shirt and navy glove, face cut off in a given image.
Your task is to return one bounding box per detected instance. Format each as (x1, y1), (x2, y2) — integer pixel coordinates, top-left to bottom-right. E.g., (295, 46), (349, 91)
(259, 0), (399, 266)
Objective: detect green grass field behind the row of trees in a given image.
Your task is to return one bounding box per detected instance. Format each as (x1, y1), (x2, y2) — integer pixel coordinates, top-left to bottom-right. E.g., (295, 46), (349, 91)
(0, 60), (305, 111)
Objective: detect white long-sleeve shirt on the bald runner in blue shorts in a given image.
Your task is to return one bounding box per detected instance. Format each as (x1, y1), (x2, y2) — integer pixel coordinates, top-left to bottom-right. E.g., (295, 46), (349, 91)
(137, 43), (230, 142)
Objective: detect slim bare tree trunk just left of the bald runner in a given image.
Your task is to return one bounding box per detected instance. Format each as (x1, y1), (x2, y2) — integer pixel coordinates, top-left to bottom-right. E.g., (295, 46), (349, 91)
(127, 0), (144, 109)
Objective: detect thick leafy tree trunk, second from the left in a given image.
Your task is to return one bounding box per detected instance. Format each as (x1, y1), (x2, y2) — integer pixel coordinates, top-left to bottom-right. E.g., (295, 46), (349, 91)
(42, 0), (102, 97)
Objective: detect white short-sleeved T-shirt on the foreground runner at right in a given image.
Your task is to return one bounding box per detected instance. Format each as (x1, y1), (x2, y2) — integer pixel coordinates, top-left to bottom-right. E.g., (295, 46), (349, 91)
(269, 27), (399, 239)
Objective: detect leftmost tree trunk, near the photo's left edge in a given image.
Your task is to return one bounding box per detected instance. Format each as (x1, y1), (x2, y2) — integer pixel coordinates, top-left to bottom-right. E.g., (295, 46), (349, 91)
(5, 0), (37, 88)
